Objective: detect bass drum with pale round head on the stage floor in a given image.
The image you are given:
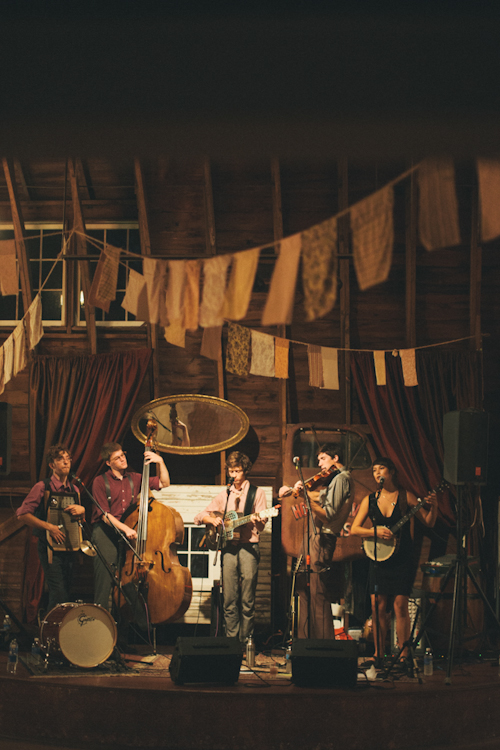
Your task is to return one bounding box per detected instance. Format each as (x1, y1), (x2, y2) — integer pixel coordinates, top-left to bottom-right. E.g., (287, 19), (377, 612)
(40, 602), (116, 669)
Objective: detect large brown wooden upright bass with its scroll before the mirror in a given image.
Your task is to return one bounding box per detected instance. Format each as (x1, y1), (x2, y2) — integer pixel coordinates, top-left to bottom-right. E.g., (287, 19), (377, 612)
(116, 419), (193, 625)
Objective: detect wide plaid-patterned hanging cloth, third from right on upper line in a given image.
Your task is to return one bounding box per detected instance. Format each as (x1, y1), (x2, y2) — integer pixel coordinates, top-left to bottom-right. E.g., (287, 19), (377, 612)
(350, 187), (394, 291)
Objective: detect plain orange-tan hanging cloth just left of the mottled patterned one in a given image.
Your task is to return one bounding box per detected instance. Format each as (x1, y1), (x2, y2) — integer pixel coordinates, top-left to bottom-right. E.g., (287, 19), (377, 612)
(262, 234), (302, 326)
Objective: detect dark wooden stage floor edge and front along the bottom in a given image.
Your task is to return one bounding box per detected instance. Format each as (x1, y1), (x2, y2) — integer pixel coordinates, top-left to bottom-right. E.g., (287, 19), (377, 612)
(0, 653), (500, 750)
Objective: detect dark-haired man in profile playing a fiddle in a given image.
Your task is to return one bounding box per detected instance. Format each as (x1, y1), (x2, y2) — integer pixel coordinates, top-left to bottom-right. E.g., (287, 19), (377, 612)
(279, 443), (354, 638)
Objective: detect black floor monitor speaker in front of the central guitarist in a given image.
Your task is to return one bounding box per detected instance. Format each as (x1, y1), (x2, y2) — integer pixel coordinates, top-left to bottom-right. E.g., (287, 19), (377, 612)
(170, 637), (243, 685)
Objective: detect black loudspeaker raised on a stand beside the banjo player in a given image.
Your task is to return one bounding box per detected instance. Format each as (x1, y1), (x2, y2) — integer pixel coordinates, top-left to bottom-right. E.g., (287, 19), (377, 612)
(443, 409), (489, 484)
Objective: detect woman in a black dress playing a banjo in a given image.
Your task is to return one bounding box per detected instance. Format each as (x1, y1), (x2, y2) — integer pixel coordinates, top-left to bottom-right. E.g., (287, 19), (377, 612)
(351, 457), (437, 665)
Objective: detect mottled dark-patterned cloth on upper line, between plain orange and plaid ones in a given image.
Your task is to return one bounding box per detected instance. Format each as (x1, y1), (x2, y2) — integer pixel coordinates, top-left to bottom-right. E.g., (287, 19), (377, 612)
(302, 218), (338, 321)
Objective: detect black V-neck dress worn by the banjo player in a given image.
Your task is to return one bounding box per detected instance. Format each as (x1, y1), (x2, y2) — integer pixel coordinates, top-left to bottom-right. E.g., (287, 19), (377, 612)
(370, 491), (415, 596)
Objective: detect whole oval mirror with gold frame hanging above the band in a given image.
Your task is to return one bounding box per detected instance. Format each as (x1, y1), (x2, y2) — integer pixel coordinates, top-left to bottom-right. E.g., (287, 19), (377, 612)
(131, 395), (250, 455)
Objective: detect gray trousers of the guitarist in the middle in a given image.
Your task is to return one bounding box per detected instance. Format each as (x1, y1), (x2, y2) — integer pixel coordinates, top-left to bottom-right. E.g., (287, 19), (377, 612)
(222, 544), (260, 642)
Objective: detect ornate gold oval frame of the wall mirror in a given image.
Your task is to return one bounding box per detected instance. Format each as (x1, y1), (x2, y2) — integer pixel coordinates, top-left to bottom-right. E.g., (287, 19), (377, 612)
(131, 394), (250, 456)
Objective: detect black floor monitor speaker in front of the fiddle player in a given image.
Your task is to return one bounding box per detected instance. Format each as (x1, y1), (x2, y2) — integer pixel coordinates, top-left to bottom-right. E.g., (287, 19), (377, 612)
(292, 638), (358, 688)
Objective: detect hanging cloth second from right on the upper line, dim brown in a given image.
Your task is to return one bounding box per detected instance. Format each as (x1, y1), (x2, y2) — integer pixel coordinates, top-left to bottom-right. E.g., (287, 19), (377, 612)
(418, 159), (460, 250)
